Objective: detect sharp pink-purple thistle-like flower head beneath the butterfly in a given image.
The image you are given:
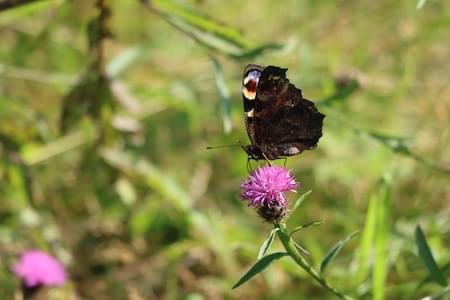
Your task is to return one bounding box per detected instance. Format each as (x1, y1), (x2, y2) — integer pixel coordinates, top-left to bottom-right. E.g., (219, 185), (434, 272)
(241, 166), (298, 222)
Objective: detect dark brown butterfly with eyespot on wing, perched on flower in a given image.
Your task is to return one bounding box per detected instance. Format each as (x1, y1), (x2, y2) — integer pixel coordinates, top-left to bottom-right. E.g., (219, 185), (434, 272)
(242, 64), (325, 160)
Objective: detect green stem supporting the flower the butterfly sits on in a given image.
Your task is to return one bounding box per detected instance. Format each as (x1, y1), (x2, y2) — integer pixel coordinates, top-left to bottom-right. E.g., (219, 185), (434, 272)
(275, 224), (353, 300)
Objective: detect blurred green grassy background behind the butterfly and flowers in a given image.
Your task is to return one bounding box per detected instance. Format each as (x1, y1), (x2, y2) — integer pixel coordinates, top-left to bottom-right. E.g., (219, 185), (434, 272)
(0, 0), (450, 299)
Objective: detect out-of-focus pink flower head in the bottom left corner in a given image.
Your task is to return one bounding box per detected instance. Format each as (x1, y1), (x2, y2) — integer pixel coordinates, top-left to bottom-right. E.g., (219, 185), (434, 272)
(13, 250), (67, 288)
